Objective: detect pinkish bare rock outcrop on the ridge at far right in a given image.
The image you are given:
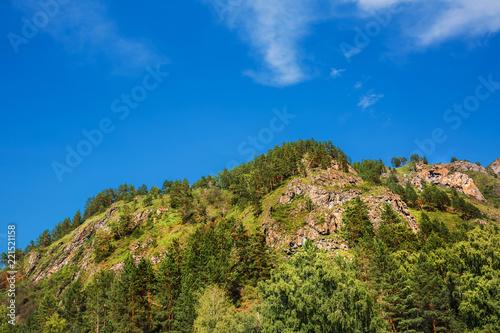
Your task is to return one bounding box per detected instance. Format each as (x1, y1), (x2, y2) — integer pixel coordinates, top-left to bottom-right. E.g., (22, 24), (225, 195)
(411, 164), (486, 201)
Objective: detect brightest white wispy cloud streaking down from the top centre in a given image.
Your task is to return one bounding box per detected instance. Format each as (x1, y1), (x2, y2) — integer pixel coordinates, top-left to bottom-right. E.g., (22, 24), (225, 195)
(211, 0), (321, 86)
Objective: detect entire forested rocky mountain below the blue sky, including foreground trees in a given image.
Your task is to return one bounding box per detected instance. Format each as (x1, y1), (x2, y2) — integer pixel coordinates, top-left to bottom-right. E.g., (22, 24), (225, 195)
(0, 140), (500, 332)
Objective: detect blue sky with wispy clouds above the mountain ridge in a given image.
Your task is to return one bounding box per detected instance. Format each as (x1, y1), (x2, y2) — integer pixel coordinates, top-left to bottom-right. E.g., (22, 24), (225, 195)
(0, 0), (500, 251)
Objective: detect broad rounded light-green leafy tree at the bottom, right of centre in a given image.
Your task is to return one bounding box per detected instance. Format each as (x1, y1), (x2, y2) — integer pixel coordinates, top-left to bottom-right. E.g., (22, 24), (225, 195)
(260, 250), (384, 332)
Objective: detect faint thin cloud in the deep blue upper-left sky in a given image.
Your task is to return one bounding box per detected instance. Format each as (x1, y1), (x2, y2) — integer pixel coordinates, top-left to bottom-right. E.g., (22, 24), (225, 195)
(15, 0), (168, 75)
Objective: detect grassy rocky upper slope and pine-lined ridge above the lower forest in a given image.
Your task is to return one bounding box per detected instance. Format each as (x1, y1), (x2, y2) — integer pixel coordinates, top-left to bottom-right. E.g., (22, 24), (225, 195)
(0, 140), (500, 330)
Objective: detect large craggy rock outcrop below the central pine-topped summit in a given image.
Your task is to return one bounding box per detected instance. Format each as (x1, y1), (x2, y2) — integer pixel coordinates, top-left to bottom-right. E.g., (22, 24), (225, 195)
(262, 168), (418, 252)
